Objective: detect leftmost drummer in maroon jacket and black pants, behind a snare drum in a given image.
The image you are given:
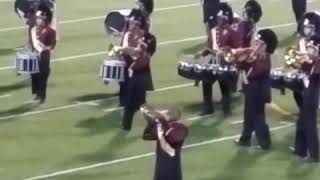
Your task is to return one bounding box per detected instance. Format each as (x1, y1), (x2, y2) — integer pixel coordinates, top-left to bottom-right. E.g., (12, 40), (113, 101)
(31, 6), (56, 104)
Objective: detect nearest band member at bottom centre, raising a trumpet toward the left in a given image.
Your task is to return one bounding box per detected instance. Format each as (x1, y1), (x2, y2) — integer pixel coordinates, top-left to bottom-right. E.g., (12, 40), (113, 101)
(141, 104), (188, 180)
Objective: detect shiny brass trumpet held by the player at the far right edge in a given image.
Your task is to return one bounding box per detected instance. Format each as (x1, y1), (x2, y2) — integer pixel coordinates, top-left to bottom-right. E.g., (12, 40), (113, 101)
(284, 47), (312, 69)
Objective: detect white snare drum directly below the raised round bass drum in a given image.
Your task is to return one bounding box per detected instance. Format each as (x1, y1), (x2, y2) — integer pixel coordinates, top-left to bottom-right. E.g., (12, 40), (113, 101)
(100, 60), (126, 82)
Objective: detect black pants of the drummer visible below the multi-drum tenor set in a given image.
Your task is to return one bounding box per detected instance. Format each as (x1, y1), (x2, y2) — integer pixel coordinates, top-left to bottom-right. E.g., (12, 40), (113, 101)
(202, 79), (232, 113)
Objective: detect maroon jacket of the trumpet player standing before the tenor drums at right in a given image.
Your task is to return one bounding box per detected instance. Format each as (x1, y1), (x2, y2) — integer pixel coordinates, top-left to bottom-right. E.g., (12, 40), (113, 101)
(239, 54), (271, 82)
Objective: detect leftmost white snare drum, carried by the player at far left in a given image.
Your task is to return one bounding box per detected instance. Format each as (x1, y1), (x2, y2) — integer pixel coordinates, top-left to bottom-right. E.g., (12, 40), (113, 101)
(15, 51), (39, 74)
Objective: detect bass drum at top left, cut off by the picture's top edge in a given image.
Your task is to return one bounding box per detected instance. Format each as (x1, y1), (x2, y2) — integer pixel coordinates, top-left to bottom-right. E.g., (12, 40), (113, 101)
(14, 0), (55, 19)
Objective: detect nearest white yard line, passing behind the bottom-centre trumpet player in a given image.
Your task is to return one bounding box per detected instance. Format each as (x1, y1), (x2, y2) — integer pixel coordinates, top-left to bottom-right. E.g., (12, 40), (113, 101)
(24, 124), (292, 180)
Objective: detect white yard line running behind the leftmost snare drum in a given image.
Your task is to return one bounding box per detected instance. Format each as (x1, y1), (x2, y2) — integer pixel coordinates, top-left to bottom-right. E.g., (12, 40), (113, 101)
(0, 23), (295, 71)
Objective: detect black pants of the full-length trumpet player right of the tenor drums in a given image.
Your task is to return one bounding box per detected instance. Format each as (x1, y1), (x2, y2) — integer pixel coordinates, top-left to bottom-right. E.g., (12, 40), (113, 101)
(240, 81), (271, 149)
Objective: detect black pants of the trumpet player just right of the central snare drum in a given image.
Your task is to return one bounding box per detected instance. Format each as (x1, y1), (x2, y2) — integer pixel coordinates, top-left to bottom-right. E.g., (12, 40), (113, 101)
(122, 73), (146, 130)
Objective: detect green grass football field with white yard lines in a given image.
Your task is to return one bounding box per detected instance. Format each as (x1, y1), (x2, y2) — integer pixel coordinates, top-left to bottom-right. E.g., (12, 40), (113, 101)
(0, 0), (320, 180)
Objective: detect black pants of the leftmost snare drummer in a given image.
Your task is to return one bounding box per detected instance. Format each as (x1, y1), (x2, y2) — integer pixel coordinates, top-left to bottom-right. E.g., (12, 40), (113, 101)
(31, 50), (50, 100)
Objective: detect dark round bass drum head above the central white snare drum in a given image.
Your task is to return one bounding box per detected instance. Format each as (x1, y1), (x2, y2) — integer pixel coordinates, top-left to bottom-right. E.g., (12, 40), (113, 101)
(104, 11), (126, 35)
